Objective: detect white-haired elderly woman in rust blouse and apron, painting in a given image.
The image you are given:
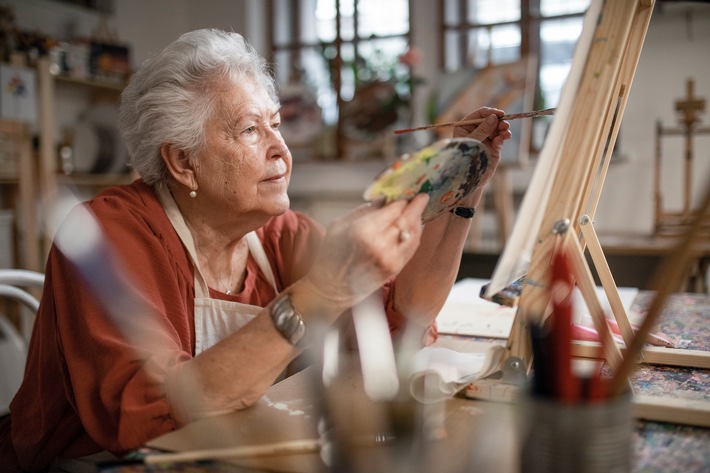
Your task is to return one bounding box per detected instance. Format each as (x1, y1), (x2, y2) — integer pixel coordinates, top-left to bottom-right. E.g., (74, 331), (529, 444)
(0, 30), (510, 471)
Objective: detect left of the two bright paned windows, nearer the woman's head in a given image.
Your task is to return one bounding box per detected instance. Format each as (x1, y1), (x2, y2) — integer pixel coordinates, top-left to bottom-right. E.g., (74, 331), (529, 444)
(268, 0), (411, 156)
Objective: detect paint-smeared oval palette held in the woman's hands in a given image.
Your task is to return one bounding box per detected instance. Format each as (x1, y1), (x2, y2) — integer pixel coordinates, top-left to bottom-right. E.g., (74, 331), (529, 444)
(363, 138), (489, 222)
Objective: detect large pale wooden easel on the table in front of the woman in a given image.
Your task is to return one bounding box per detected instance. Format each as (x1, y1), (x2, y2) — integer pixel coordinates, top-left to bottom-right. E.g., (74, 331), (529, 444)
(472, 0), (710, 418)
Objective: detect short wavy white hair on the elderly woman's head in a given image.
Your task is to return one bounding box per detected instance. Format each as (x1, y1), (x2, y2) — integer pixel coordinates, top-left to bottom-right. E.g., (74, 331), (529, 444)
(119, 29), (278, 184)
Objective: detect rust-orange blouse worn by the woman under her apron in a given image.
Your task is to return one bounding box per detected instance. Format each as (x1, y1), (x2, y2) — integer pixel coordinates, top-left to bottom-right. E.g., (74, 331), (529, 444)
(0, 180), (412, 471)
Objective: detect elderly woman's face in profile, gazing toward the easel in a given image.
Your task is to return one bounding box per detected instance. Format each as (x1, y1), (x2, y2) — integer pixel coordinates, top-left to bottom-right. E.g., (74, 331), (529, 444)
(195, 80), (291, 219)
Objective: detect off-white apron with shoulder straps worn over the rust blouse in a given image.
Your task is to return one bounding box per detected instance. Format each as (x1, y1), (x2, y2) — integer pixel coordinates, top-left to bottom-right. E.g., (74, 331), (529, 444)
(155, 185), (279, 356)
